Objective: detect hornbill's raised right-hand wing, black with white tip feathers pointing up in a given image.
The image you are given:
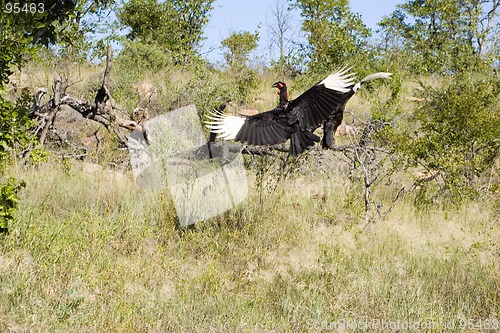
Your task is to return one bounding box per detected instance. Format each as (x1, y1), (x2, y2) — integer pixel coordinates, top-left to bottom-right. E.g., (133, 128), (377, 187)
(289, 68), (354, 130)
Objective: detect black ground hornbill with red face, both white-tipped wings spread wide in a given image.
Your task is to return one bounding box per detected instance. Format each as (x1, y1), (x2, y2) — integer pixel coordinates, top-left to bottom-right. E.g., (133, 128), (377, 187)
(205, 68), (390, 155)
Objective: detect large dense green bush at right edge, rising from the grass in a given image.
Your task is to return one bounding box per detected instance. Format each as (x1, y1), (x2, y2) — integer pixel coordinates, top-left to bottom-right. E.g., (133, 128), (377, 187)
(399, 74), (500, 199)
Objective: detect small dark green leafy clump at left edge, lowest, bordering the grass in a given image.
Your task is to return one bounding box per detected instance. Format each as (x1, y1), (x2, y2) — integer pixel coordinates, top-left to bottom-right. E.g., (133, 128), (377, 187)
(0, 178), (26, 233)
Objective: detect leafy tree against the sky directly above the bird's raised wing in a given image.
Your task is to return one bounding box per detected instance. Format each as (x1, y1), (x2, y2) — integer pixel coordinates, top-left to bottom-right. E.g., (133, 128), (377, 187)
(293, 0), (371, 71)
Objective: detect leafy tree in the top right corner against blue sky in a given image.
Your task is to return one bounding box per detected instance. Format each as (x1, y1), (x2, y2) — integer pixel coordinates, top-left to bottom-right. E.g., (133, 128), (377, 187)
(379, 0), (500, 73)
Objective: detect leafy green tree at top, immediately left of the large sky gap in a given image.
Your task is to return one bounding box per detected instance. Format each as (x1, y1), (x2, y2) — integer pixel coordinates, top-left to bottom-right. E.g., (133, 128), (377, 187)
(118, 0), (215, 65)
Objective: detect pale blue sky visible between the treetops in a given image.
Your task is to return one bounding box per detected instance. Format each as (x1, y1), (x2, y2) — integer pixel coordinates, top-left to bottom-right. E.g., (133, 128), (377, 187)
(202, 0), (405, 63)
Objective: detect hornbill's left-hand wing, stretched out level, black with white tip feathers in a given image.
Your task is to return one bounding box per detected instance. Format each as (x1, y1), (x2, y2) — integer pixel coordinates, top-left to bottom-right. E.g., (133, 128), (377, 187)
(205, 110), (294, 145)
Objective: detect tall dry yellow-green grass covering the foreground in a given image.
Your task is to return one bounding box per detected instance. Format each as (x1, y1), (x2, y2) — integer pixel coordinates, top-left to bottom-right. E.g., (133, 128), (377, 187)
(0, 157), (500, 332)
